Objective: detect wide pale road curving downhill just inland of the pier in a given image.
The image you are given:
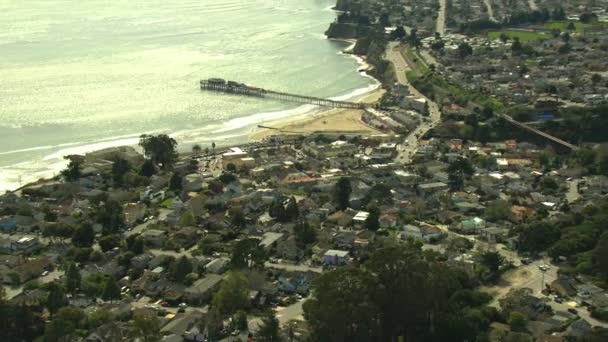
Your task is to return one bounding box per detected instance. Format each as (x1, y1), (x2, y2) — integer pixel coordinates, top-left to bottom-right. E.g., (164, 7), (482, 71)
(385, 42), (441, 164)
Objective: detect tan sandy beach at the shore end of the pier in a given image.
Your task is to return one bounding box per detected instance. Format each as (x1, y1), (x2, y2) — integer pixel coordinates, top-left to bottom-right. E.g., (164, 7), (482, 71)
(250, 88), (384, 140)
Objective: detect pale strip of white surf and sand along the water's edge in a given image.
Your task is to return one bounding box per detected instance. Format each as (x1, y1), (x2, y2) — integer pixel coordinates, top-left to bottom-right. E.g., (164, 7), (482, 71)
(0, 8), (384, 193)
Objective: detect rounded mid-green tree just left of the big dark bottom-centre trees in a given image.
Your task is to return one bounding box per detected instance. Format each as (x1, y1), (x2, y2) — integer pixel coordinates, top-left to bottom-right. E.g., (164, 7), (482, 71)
(213, 272), (249, 315)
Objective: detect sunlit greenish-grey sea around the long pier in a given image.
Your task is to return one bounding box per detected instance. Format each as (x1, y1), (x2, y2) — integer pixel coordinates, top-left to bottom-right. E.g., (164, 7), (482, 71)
(0, 0), (377, 192)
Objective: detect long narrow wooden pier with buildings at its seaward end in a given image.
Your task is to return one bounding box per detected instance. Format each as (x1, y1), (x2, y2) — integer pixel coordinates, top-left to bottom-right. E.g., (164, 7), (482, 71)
(201, 78), (367, 109)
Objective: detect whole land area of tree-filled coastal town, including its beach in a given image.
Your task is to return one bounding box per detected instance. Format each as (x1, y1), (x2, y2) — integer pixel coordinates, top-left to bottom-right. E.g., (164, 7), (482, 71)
(0, 0), (608, 342)
